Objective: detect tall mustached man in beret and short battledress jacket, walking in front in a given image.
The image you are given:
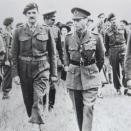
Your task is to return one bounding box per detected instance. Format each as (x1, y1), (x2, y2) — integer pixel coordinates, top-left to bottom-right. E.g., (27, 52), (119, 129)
(12, 3), (57, 131)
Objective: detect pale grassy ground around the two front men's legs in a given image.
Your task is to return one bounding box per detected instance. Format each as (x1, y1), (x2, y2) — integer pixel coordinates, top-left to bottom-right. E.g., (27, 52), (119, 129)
(0, 81), (131, 131)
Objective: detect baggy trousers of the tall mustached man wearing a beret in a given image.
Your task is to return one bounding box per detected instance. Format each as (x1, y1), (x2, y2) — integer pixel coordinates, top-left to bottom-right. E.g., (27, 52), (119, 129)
(18, 60), (49, 124)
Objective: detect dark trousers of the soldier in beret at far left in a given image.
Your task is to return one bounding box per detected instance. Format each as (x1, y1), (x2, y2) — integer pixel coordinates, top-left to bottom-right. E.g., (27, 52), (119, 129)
(2, 65), (12, 93)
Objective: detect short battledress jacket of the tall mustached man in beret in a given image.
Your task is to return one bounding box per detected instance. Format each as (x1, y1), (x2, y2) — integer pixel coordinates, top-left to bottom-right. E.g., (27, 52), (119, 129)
(12, 24), (57, 76)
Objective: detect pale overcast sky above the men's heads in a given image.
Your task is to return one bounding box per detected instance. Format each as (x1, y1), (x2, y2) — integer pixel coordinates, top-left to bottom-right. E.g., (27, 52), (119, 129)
(0, 0), (131, 25)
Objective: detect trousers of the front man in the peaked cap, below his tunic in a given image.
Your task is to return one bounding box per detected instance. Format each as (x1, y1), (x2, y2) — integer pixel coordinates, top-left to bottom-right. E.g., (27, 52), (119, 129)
(69, 88), (98, 131)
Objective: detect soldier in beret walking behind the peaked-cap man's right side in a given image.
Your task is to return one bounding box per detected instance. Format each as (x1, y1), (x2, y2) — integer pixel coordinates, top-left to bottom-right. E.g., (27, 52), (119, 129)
(105, 13), (127, 95)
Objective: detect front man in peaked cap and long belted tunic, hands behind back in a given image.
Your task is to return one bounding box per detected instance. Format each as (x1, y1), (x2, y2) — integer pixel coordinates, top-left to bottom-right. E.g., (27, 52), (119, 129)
(64, 8), (104, 131)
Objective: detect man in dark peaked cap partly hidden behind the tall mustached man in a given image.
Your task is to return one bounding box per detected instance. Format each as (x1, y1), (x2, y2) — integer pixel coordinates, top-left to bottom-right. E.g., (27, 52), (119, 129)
(43, 11), (63, 111)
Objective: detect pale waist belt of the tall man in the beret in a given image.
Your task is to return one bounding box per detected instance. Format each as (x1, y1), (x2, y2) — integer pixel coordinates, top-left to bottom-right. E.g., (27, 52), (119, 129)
(19, 56), (47, 61)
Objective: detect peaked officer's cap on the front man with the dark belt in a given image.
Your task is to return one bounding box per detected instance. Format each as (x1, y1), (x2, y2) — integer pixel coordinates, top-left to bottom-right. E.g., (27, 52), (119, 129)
(71, 7), (91, 19)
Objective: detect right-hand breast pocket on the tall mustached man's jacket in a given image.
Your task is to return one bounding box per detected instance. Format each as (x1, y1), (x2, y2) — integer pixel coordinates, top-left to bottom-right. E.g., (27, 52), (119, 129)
(36, 34), (49, 50)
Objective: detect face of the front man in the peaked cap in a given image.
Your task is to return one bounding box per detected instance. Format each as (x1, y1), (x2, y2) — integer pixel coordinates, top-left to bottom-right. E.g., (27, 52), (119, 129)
(74, 19), (87, 31)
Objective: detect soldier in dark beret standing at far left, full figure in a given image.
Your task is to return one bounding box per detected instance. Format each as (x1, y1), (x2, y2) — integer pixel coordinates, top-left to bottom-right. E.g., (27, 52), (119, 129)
(2, 17), (14, 99)
